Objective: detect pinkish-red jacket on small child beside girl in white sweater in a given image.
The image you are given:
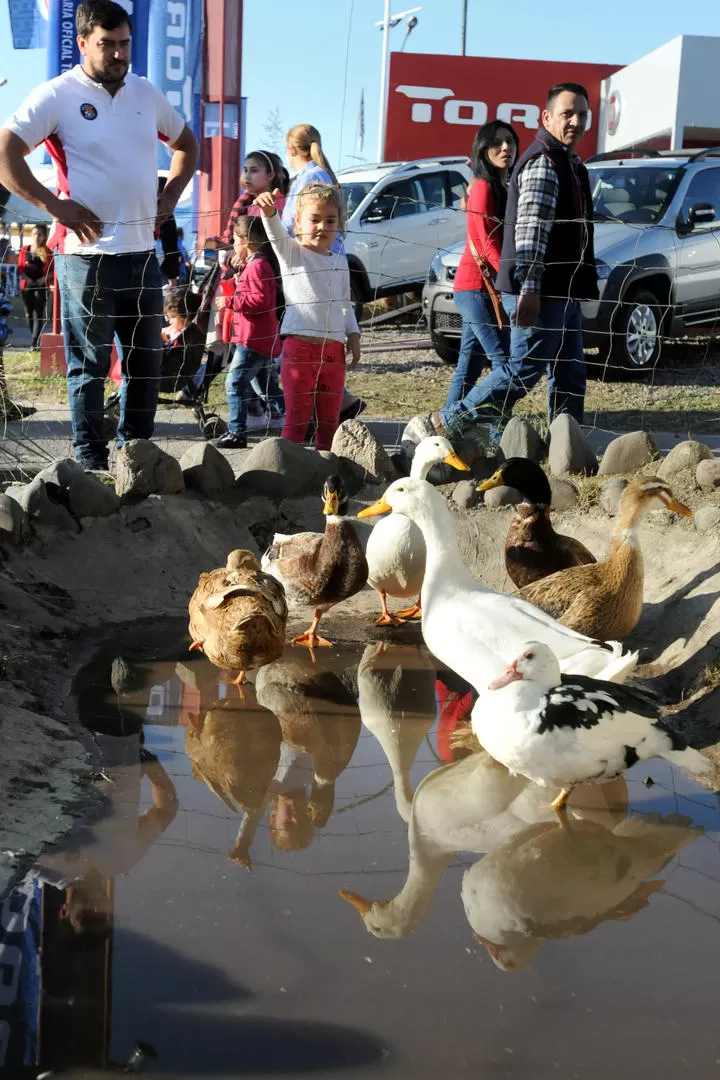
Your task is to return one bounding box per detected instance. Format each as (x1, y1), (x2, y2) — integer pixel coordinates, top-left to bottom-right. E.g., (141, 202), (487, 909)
(232, 254), (281, 357)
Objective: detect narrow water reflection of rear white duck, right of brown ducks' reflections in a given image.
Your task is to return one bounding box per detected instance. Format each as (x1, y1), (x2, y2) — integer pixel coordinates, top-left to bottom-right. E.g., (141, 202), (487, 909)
(357, 643), (436, 822)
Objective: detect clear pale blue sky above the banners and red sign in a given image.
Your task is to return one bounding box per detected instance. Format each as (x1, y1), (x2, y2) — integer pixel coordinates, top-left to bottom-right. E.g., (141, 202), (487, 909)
(5, 0), (720, 170)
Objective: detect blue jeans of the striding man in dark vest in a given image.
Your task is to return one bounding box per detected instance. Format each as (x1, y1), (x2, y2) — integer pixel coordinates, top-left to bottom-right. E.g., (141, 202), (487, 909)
(440, 293), (586, 436)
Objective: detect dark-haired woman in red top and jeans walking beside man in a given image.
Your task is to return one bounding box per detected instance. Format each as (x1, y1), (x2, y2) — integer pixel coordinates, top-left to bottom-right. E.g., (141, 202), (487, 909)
(440, 120), (518, 406)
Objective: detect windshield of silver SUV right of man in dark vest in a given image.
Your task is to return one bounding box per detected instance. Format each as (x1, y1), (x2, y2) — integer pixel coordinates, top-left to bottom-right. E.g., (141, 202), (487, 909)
(589, 164), (680, 225)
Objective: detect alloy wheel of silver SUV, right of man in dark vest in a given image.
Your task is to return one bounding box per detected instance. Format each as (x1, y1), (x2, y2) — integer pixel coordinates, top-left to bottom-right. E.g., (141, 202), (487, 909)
(608, 288), (663, 379)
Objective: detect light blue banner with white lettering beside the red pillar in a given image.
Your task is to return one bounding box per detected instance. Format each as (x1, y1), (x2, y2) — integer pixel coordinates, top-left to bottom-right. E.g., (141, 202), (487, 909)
(148, 0), (203, 153)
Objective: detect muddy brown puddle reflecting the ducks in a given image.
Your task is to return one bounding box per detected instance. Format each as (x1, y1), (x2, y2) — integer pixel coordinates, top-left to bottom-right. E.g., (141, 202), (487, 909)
(0, 625), (720, 1080)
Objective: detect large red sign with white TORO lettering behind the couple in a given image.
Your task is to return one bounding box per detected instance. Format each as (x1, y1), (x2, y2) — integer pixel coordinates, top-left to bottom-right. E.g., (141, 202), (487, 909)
(385, 53), (619, 161)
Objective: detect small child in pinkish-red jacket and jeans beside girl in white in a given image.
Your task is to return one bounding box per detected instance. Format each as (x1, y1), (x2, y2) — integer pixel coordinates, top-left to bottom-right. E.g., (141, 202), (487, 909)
(215, 216), (281, 450)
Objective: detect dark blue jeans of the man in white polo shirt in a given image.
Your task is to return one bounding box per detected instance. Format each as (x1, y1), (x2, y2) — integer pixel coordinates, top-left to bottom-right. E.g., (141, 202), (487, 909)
(55, 252), (163, 469)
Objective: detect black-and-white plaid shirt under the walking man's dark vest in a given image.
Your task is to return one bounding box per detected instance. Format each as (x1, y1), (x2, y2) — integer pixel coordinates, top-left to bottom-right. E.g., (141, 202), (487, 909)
(515, 153), (580, 293)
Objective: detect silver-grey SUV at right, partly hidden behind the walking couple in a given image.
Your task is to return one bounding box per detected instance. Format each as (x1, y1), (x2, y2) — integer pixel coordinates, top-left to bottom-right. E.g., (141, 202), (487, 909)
(423, 147), (720, 376)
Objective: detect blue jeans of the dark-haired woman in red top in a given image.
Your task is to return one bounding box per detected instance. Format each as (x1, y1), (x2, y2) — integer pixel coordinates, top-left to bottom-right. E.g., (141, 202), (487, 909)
(445, 288), (510, 408)
